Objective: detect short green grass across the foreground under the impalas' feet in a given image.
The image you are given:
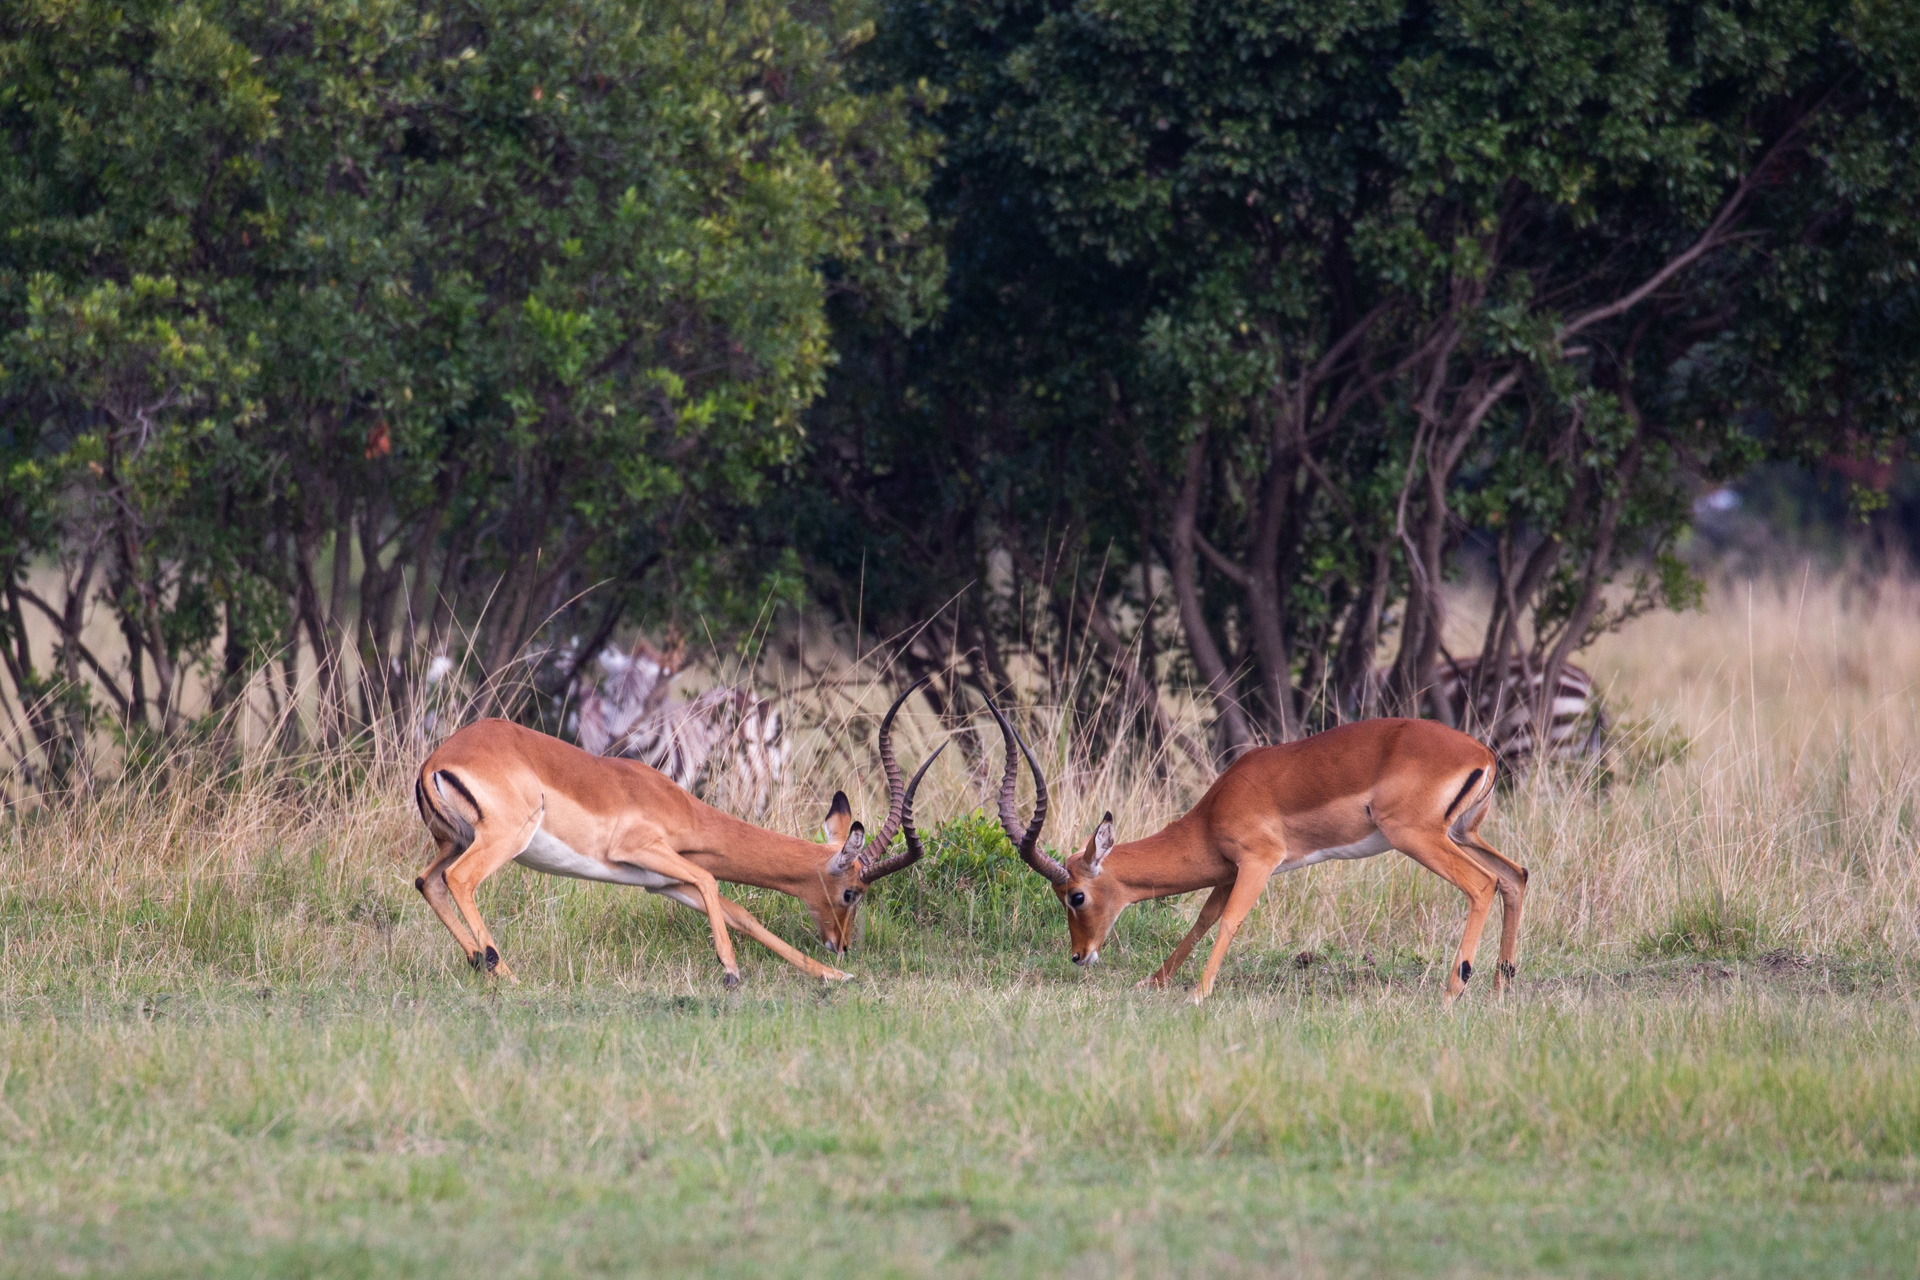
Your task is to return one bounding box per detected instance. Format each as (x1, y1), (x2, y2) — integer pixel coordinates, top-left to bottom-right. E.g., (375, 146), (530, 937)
(0, 827), (1920, 1276)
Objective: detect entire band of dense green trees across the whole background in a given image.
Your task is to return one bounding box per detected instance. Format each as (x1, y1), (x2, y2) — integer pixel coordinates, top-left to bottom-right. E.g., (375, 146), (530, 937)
(0, 0), (1920, 785)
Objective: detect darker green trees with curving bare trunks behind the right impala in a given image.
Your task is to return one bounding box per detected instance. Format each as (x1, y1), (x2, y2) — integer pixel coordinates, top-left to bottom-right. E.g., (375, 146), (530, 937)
(820, 0), (1920, 747)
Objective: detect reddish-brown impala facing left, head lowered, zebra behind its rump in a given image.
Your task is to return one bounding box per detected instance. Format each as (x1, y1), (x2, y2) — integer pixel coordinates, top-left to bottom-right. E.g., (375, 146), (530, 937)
(987, 700), (1526, 1004)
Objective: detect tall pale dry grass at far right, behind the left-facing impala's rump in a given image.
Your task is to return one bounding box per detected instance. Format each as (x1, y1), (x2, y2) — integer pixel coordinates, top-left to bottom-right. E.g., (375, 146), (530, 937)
(1505, 572), (1920, 956)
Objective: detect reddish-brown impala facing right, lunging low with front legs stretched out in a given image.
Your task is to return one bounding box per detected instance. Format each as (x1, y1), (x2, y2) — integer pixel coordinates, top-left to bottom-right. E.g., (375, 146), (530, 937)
(413, 679), (945, 986)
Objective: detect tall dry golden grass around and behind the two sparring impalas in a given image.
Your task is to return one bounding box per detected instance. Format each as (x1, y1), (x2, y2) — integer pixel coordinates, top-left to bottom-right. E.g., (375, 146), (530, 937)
(0, 572), (1920, 992)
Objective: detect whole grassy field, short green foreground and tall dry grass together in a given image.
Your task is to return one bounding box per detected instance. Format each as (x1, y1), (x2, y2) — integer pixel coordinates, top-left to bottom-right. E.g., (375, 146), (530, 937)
(0, 578), (1920, 1276)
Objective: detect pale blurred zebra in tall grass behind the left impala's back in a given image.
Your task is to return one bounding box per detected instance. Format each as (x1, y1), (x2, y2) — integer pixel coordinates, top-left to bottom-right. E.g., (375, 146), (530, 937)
(574, 641), (793, 812)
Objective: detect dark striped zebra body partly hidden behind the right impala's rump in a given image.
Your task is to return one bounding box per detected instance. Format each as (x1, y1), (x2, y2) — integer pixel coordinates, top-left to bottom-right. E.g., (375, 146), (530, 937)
(1428, 656), (1607, 773)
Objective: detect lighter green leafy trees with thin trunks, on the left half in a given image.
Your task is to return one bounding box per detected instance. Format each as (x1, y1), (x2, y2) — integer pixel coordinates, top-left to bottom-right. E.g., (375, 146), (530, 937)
(0, 0), (941, 782)
